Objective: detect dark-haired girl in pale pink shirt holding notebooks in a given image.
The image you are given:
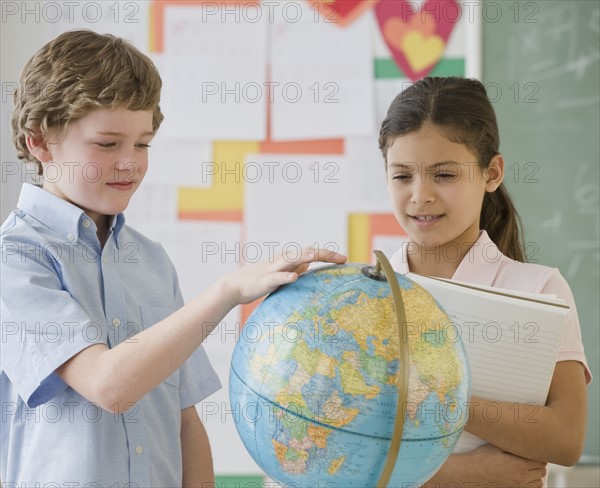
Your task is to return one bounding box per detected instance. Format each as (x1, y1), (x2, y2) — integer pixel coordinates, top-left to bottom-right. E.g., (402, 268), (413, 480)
(379, 78), (591, 487)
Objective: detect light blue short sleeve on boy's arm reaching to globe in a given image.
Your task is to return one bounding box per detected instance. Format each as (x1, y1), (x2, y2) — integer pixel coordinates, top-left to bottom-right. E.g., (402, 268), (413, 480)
(1, 239), (105, 408)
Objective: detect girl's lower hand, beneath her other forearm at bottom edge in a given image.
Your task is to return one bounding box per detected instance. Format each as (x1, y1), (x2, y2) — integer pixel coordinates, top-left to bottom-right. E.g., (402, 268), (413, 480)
(468, 444), (546, 488)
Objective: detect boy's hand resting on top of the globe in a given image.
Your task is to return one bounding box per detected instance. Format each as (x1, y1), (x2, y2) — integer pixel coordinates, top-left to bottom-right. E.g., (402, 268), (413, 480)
(224, 247), (348, 306)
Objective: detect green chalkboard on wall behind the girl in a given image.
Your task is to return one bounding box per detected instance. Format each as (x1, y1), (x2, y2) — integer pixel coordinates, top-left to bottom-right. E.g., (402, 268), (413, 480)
(482, 0), (600, 458)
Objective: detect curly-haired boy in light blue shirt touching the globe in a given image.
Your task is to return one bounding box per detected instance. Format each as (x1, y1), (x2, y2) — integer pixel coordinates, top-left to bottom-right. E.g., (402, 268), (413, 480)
(0, 31), (345, 487)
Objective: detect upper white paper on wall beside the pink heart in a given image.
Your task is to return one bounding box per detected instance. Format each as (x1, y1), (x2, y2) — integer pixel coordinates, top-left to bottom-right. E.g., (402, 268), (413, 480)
(269, 2), (375, 140)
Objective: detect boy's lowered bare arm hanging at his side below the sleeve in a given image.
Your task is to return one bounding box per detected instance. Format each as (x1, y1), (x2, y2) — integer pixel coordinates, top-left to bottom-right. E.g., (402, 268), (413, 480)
(181, 406), (215, 488)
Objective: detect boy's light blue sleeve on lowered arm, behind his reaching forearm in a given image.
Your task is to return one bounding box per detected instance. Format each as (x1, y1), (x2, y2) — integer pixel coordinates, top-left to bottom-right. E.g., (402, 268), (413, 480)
(173, 268), (221, 410)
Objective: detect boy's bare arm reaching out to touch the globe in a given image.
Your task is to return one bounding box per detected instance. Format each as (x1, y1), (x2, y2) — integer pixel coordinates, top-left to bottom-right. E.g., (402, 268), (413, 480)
(56, 249), (346, 413)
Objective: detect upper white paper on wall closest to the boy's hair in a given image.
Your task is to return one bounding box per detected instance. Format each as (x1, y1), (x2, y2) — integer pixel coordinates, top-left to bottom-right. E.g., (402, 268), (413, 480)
(163, 2), (267, 140)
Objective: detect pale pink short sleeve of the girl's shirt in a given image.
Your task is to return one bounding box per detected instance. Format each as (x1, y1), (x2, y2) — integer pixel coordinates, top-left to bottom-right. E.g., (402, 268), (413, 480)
(540, 269), (592, 384)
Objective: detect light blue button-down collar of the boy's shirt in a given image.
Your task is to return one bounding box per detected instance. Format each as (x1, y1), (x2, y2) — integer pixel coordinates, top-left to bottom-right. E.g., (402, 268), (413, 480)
(17, 183), (125, 246)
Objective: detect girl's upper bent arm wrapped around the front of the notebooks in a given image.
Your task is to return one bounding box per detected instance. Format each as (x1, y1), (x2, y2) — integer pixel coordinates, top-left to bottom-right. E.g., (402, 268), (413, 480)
(465, 361), (587, 466)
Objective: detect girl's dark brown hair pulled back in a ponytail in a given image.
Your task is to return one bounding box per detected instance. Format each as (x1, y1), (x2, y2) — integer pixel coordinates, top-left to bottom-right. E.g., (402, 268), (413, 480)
(379, 77), (525, 262)
